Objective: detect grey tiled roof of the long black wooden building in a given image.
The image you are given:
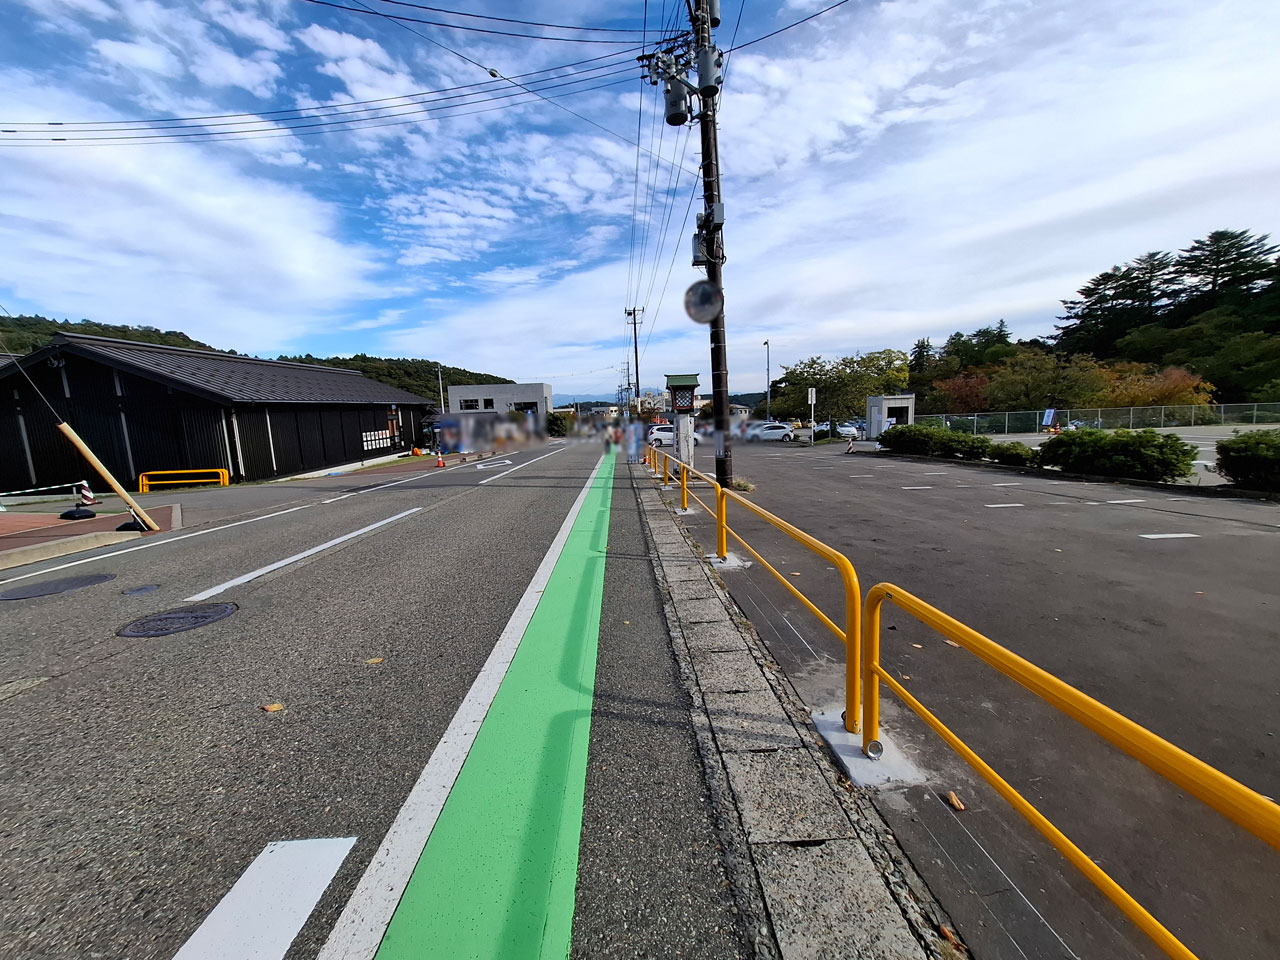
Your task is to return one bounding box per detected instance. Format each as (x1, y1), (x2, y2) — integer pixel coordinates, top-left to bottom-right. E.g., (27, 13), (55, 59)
(42, 333), (431, 404)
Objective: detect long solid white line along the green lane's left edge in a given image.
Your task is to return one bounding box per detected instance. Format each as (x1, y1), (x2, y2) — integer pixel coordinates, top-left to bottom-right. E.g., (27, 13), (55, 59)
(316, 457), (604, 960)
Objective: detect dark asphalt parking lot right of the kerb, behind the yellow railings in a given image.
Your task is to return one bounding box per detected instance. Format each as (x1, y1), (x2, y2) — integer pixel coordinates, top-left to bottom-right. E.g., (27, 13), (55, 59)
(687, 444), (1280, 960)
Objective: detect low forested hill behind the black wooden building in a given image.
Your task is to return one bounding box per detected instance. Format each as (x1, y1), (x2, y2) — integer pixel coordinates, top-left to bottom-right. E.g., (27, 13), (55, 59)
(0, 316), (515, 401)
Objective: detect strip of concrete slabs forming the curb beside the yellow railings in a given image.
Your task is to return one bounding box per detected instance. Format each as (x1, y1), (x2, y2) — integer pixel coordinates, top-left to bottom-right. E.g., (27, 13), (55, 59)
(631, 465), (963, 960)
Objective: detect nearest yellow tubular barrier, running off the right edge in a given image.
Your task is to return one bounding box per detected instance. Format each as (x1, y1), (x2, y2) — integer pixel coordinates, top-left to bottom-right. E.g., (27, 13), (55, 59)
(849, 584), (1280, 960)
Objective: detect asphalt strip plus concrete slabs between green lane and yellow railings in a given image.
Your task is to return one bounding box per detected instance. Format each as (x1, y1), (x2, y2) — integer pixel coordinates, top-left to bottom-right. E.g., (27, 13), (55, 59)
(572, 463), (965, 960)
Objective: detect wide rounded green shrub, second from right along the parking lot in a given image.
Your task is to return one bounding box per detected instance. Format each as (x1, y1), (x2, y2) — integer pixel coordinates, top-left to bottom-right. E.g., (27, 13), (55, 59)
(1039, 430), (1196, 480)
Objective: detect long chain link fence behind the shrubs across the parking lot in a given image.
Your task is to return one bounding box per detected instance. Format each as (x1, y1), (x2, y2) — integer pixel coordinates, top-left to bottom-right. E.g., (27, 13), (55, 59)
(915, 403), (1280, 435)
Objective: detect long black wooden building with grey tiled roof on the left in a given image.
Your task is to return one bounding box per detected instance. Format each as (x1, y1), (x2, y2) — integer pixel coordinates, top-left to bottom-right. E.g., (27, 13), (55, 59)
(0, 334), (436, 490)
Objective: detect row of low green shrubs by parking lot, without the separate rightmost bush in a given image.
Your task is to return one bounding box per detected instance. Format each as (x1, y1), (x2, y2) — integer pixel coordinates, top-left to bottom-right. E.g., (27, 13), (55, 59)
(879, 424), (1198, 480)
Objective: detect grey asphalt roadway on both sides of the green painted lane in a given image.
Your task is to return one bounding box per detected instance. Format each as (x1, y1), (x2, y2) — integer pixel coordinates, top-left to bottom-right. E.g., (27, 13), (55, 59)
(0, 444), (750, 960)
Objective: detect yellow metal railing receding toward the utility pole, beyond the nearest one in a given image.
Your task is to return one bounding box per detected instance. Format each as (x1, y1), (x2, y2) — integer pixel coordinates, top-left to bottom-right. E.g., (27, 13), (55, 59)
(645, 447), (863, 733)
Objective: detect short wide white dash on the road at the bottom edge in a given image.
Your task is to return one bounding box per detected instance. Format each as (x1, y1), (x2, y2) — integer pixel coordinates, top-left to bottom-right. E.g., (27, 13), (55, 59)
(174, 837), (356, 960)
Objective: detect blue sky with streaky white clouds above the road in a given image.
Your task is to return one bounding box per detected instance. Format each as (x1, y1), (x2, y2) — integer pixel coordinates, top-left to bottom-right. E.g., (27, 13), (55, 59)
(0, 0), (1280, 397)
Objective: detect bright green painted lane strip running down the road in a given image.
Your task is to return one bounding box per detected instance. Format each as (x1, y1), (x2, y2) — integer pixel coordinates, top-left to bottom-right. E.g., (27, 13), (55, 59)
(376, 457), (616, 960)
